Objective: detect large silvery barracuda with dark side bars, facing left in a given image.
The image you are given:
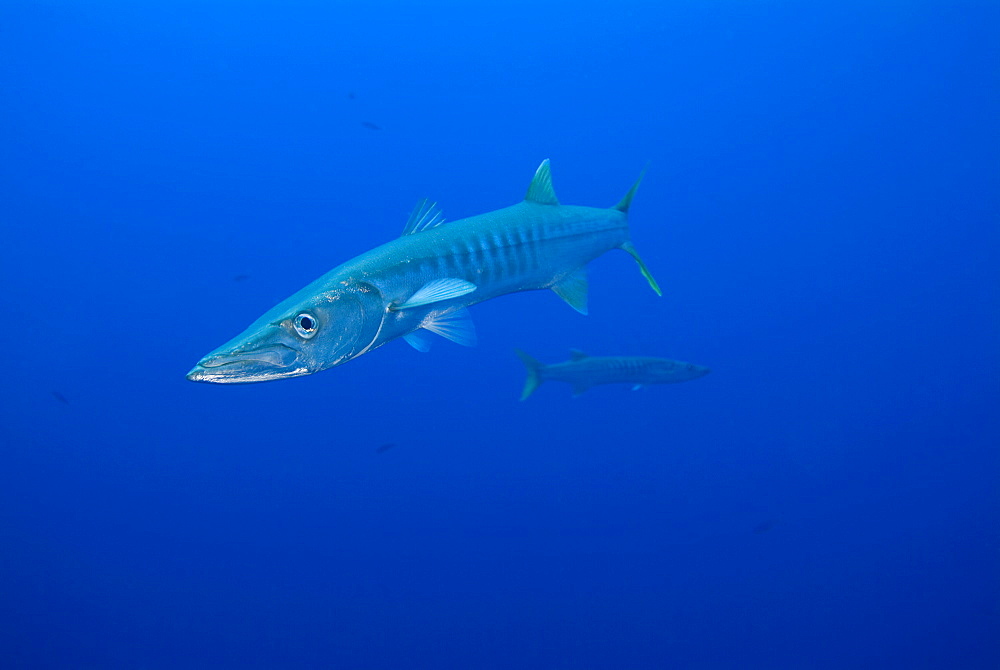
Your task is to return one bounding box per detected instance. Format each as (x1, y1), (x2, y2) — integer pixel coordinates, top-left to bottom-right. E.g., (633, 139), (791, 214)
(187, 160), (660, 384)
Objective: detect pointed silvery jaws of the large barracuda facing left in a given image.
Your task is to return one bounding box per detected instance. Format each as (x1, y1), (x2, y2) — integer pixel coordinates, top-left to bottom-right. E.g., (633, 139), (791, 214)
(187, 344), (309, 384)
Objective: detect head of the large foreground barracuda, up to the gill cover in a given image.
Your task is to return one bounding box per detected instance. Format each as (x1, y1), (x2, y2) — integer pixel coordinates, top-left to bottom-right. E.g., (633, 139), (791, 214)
(187, 283), (386, 384)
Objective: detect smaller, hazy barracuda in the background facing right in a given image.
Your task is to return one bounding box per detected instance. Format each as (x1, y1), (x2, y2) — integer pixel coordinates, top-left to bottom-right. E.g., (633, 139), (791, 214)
(514, 349), (711, 400)
